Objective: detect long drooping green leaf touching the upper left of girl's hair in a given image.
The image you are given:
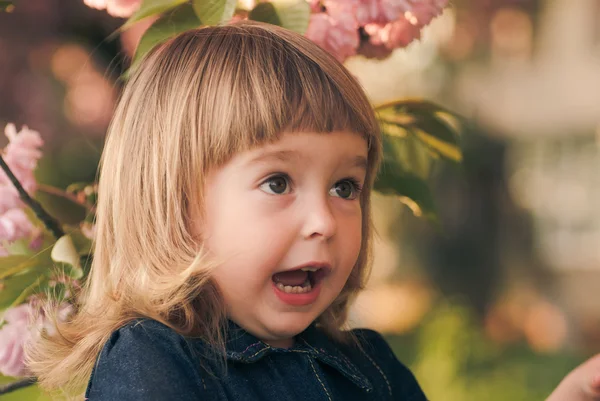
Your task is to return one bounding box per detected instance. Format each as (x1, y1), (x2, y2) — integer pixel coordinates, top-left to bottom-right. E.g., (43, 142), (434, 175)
(130, 4), (201, 69)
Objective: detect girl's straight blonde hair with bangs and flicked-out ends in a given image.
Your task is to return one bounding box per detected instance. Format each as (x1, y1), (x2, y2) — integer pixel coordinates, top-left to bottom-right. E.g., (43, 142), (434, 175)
(27, 21), (381, 393)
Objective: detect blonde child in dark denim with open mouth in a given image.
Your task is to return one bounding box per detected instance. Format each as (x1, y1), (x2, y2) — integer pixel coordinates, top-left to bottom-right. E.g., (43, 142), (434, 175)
(28, 22), (593, 401)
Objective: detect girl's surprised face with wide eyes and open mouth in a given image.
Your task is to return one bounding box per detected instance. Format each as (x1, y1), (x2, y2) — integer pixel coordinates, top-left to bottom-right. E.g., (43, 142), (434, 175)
(198, 132), (367, 347)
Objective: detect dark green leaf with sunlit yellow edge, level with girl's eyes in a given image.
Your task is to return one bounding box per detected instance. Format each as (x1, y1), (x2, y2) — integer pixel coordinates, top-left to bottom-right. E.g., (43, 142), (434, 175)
(374, 160), (436, 220)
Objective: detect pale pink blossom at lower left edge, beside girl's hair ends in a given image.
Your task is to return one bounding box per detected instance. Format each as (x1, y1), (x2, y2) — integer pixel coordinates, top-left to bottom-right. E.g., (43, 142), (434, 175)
(0, 304), (32, 376)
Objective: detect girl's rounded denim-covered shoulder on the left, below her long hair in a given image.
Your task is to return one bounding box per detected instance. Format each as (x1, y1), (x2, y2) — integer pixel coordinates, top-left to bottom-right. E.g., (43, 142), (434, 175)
(86, 319), (203, 400)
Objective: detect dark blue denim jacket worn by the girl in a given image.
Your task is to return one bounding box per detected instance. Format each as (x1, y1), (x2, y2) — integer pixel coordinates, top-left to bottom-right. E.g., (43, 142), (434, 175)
(85, 319), (426, 401)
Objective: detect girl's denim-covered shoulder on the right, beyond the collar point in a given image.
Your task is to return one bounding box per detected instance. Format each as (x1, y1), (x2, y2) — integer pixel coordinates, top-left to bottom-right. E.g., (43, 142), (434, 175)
(352, 328), (427, 401)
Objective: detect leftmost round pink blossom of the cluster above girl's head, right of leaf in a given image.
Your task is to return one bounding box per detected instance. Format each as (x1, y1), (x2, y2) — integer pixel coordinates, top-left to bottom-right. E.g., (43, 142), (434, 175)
(305, 8), (360, 62)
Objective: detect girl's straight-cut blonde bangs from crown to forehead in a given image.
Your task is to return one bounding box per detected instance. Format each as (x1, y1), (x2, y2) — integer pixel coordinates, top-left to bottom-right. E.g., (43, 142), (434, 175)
(178, 21), (378, 168)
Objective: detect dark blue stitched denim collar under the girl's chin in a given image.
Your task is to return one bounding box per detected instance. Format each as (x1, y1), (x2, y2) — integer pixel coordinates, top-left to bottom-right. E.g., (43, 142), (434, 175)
(225, 320), (373, 392)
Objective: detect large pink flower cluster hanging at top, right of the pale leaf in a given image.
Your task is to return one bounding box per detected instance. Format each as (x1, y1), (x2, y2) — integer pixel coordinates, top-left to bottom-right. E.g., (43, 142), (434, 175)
(306, 0), (448, 62)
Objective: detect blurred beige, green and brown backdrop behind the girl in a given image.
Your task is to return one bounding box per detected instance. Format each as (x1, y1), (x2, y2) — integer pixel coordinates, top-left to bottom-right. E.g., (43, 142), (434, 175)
(0, 0), (600, 401)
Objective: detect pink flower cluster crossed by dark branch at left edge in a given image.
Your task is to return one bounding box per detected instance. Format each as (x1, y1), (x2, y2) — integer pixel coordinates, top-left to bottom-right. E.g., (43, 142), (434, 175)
(0, 124), (43, 256)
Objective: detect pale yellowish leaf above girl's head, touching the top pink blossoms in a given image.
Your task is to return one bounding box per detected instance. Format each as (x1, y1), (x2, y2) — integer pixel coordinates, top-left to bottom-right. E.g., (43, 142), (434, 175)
(249, 0), (310, 34)
